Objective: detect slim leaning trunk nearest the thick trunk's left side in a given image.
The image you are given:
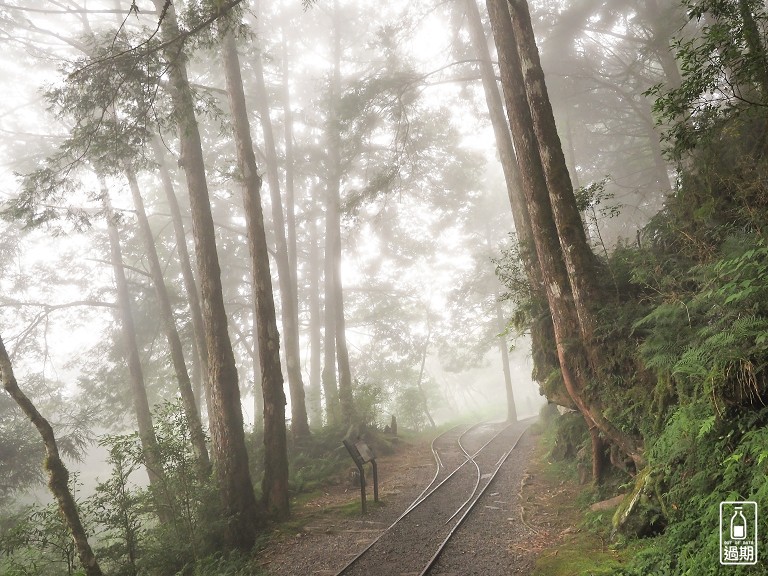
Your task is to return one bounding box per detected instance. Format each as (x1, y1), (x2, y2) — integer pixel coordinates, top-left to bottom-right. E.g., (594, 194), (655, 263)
(152, 136), (211, 415)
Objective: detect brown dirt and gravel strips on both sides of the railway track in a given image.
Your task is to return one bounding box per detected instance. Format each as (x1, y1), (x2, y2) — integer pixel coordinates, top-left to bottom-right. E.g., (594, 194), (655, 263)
(263, 418), (560, 576)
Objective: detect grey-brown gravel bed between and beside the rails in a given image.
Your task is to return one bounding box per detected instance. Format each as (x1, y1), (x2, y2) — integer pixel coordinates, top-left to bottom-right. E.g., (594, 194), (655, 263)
(264, 421), (533, 576)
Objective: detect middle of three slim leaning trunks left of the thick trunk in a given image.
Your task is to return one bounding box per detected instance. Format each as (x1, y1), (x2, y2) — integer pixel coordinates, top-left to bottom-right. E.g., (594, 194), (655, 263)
(125, 167), (211, 476)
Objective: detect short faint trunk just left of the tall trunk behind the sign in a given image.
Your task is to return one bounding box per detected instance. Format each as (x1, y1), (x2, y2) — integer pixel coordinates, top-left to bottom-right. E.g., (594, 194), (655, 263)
(307, 211), (323, 428)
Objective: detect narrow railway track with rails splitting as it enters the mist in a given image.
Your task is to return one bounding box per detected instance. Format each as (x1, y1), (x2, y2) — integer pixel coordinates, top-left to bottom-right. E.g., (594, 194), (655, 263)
(336, 422), (529, 576)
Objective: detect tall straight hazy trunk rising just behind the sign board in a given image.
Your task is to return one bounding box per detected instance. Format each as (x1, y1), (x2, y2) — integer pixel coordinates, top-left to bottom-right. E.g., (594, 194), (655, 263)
(325, 0), (355, 425)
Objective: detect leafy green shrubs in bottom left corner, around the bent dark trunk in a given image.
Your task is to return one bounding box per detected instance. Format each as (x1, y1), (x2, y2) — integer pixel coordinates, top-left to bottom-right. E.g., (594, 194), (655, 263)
(0, 401), (225, 576)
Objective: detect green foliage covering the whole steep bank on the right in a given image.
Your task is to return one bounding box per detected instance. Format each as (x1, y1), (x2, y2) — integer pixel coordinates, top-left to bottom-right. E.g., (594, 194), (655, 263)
(503, 5), (768, 564)
